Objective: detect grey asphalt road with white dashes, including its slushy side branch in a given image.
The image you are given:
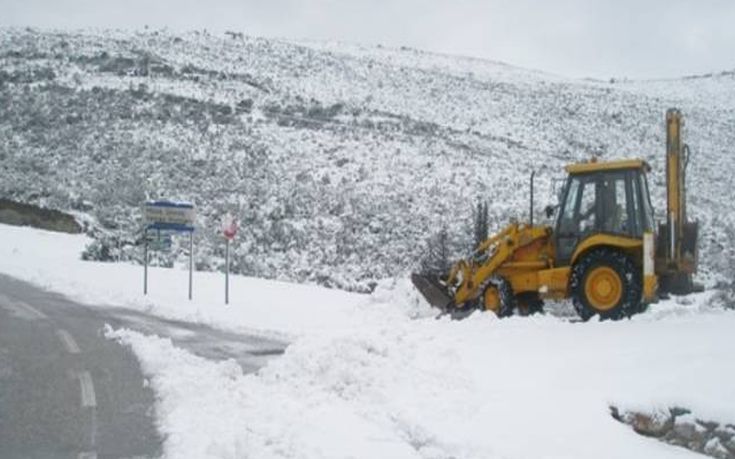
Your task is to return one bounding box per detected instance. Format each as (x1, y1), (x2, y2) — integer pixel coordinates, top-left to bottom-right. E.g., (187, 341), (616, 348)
(0, 275), (286, 459)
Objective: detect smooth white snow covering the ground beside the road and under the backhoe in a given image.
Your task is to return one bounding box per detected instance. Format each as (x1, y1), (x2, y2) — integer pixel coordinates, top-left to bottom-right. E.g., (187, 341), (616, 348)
(0, 225), (735, 458)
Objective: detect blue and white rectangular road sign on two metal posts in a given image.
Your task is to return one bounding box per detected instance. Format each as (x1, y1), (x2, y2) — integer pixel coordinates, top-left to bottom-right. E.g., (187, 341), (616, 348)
(143, 201), (195, 300)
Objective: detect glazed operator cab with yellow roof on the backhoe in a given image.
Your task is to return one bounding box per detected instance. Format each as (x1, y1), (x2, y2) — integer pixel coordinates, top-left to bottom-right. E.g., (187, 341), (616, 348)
(554, 160), (653, 266)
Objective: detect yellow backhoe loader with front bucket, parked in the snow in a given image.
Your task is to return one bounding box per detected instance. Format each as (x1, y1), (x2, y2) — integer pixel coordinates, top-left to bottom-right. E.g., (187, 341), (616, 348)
(412, 109), (698, 320)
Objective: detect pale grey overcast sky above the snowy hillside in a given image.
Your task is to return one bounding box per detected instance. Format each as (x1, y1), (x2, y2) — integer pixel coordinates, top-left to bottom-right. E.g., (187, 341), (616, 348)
(0, 0), (735, 78)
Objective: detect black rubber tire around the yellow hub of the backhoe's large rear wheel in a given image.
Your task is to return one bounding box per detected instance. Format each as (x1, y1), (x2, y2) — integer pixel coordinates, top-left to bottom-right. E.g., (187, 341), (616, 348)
(569, 248), (643, 320)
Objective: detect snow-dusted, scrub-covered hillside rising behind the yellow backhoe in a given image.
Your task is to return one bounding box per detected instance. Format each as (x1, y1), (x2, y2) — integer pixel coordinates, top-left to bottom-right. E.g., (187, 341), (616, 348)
(0, 29), (735, 289)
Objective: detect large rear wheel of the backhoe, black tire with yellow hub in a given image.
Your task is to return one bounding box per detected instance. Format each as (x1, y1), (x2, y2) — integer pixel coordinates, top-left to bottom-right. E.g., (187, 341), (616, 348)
(570, 248), (643, 320)
